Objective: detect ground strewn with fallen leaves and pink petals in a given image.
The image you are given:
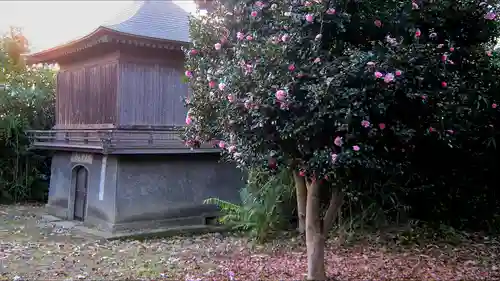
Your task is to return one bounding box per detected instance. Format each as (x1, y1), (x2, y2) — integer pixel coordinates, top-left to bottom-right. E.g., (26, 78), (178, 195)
(0, 205), (500, 281)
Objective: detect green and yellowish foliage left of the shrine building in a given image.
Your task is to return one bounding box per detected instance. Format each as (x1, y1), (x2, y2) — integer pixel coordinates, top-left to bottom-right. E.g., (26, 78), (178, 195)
(0, 29), (55, 202)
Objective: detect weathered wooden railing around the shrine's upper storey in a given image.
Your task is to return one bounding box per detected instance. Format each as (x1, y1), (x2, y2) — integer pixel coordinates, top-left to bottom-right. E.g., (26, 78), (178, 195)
(28, 129), (217, 153)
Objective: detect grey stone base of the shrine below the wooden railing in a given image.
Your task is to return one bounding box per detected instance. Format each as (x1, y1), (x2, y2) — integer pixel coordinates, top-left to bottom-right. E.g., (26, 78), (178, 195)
(47, 152), (244, 236)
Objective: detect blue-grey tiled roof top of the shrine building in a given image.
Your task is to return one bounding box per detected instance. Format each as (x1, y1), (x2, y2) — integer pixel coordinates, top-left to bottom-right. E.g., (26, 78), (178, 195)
(102, 0), (190, 42)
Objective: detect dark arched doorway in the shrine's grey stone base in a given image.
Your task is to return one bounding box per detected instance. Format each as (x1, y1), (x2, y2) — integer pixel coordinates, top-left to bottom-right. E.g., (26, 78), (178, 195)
(73, 166), (89, 221)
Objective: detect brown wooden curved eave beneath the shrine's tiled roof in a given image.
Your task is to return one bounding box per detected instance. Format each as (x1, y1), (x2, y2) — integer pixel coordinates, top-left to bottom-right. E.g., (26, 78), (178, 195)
(26, 26), (189, 64)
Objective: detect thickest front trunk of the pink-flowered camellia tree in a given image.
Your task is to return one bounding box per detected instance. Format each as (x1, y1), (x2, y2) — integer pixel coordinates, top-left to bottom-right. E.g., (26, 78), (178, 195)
(306, 180), (326, 281)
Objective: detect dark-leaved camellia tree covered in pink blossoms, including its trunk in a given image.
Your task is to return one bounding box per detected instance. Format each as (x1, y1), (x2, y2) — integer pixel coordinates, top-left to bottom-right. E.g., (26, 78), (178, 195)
(185, 0), (500, 280)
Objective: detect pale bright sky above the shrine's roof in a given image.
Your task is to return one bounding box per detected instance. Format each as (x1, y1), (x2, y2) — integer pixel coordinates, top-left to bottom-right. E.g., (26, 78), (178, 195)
(0, 0), (197, 52)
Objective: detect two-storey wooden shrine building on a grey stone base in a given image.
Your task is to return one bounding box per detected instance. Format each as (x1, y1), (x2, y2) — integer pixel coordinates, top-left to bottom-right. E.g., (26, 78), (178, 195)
(28, 0), (243, 233)
